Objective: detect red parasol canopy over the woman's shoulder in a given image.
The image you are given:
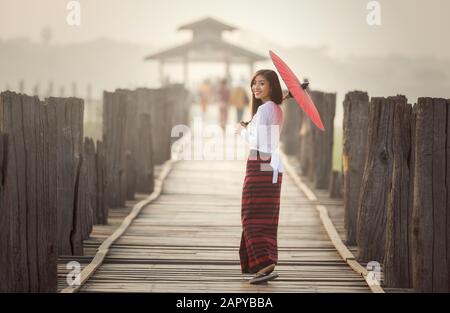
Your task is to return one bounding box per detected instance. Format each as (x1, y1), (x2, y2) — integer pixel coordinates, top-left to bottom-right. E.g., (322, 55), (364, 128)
(269, 50), (325, 130)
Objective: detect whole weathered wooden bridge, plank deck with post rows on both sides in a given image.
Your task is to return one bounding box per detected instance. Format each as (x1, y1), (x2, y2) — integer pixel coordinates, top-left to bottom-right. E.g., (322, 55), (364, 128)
(0, 85), (450, 293)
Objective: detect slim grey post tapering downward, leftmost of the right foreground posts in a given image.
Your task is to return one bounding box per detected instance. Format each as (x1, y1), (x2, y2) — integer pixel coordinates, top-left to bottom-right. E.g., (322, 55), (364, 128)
(342, 91), (369, 245)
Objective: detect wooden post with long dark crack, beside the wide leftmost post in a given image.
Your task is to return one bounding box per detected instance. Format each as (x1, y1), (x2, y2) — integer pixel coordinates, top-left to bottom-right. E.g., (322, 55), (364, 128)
(46, 97), (85, 255)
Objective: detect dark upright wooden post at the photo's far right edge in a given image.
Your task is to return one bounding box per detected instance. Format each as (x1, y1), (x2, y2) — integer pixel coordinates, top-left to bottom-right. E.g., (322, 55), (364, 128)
(412, 98), (450, 292)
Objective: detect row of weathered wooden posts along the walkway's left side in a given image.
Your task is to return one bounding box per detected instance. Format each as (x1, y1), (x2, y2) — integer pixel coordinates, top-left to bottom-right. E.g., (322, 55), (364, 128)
(0, 85), (189, 292)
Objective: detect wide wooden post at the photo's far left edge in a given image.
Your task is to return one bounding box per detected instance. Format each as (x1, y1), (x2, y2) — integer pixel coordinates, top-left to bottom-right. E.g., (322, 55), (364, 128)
(0, 92), (57, 292)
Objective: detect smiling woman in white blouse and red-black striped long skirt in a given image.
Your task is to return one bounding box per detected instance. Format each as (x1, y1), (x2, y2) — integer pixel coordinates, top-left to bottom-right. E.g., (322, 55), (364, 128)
(236, 70), (283, 284)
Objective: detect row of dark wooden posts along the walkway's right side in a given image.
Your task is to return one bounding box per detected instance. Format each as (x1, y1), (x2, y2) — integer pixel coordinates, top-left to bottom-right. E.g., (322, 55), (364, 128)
(283, 91), (450, 292)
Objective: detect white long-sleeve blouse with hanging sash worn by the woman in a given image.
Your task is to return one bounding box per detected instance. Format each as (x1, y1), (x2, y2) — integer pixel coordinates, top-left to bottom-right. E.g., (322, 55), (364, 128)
(240, 101), (283, 183)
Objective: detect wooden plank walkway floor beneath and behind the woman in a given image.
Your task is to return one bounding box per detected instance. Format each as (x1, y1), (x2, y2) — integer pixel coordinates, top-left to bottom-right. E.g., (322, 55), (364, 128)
(74, 157), (370, 292)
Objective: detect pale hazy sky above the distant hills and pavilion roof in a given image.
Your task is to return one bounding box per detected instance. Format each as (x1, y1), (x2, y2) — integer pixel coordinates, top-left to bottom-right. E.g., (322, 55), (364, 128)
(0, 0), (450, 57)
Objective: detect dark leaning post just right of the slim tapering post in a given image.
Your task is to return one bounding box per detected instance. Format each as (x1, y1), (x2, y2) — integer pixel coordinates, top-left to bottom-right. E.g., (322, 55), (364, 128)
(356, 96), (406, 264)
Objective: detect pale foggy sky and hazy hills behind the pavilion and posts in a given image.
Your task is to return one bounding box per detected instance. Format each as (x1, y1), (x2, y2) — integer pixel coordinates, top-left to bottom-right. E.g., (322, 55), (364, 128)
(0, 0), (450, 124)
